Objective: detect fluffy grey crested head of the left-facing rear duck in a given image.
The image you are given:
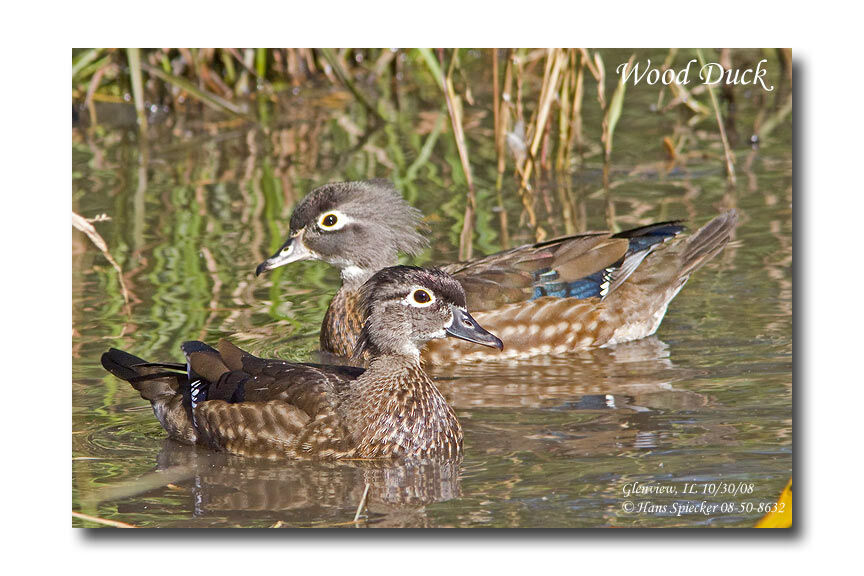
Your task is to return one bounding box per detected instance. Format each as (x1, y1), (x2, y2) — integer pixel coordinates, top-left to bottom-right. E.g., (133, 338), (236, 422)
(258, 179), (428, 284)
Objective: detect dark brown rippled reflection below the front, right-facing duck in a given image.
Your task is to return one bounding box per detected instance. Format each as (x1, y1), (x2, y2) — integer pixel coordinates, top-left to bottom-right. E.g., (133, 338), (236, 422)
(109, 439), (462, 527)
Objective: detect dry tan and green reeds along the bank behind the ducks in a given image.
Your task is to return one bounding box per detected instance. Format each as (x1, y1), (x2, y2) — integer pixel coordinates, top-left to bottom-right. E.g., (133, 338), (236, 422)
(72, 48), (791, 253)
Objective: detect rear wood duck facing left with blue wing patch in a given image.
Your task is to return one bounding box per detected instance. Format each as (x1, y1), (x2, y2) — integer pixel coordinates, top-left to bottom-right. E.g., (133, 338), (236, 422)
(256, 180), (738, 365)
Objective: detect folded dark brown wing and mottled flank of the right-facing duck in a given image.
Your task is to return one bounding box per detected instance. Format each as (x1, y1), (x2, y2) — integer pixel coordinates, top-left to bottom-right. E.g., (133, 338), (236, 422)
(183, 340), (363, 458)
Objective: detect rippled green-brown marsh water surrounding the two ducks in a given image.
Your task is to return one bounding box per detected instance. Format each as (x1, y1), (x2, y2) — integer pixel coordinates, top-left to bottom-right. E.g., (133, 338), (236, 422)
(72, 52), (793, 527)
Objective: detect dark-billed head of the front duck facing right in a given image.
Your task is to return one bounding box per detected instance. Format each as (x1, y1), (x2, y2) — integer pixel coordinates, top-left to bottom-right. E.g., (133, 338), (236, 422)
(354, 266), (503, 358)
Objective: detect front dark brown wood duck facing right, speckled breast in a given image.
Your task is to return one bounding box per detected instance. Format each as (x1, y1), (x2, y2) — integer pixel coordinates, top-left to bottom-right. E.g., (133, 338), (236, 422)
(102, 266), (502, 459)
